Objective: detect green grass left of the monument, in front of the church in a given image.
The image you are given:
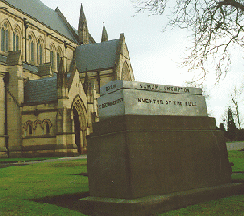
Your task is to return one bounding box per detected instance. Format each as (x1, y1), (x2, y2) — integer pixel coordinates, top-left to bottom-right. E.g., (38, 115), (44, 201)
(0, 159), (89, 216)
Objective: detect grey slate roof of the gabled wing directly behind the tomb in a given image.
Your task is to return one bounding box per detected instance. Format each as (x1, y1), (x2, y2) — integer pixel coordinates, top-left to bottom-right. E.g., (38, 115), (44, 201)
(75, 39), (120, 73)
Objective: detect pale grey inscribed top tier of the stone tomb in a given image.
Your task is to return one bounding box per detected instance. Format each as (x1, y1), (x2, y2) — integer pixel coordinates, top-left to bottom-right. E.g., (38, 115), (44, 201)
(98, 80), (207, 120)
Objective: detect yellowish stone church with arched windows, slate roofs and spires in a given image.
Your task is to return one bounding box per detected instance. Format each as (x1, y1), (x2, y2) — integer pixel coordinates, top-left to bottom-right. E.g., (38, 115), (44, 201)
(0, 0), (134, 157)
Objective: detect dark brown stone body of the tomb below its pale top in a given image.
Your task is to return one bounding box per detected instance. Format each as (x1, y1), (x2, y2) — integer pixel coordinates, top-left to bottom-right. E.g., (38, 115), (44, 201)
(83, 115), (234, 214)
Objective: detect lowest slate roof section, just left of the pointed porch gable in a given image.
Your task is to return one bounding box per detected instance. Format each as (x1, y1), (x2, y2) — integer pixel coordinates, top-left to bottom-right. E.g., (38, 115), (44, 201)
(24, 75), (58, 103)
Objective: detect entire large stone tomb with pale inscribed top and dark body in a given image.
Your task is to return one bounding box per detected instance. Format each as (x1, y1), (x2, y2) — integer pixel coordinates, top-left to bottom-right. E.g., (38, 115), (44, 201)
(82, 81), (231, 216)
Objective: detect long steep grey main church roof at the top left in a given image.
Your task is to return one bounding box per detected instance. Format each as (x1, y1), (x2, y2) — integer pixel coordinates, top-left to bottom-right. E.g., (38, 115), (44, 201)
(2, 0), (77, 42)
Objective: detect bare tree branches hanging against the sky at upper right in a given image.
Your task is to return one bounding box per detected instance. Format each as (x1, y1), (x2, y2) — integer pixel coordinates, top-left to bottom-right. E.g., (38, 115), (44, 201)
(131, 0), (244, 80)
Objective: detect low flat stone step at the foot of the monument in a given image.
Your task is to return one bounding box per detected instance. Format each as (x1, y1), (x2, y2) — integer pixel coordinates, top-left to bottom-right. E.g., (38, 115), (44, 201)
(81, 183), (244, 216)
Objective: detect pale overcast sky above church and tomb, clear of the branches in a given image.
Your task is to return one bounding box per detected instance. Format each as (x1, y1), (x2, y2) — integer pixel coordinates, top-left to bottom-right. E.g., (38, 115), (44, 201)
(41, 0), (243, 124)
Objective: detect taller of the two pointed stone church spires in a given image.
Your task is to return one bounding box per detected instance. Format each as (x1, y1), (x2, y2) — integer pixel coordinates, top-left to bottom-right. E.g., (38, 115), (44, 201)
(78, 4), (89, 44)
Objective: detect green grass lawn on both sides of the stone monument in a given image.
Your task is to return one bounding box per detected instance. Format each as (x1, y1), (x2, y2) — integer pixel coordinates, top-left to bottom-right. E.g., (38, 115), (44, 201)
(0, 151), (244, 216)
